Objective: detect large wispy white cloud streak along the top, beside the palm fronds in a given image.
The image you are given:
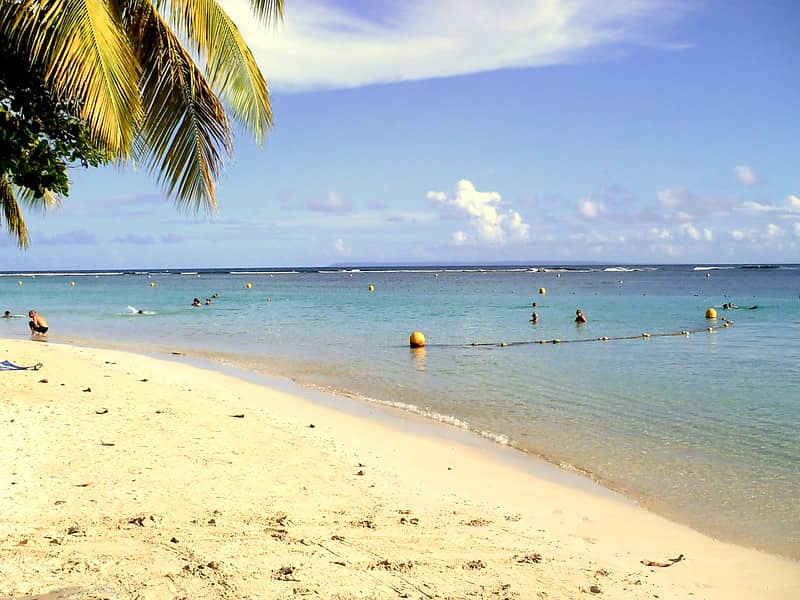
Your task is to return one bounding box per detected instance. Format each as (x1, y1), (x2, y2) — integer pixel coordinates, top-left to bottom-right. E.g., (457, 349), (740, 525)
(220, 0), (692, 90)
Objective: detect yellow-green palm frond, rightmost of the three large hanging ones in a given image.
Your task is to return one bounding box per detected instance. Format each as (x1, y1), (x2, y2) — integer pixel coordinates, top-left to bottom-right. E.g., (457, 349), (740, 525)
(159, 0), (276, 144)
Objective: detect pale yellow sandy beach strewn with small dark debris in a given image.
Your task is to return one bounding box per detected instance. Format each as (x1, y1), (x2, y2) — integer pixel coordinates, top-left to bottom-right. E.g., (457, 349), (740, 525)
(0, 339), (800, 599)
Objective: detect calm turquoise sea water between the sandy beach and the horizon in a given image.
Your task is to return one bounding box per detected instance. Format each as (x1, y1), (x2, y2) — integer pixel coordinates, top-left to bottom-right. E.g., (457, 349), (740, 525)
(0, 265), (800, 558)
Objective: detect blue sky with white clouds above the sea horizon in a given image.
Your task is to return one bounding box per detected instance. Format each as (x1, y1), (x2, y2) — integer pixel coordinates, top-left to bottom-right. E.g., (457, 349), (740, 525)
(0, 0), (800, 270)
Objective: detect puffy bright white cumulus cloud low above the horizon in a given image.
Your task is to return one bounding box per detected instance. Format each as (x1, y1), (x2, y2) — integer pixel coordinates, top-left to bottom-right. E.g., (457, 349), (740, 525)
(428, 179), (531, 245)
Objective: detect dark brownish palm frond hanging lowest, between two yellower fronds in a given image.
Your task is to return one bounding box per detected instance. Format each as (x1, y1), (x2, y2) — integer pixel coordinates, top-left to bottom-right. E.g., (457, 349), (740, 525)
(124, 0), (232, 210)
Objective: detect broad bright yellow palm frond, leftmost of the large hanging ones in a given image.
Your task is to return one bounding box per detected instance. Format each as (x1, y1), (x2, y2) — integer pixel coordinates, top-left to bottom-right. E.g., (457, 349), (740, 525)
(0, 0), (141, 158)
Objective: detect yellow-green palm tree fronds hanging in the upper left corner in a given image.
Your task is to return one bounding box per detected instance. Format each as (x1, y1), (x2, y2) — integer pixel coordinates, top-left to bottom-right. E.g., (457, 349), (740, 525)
(0, 0), (283, 245)
